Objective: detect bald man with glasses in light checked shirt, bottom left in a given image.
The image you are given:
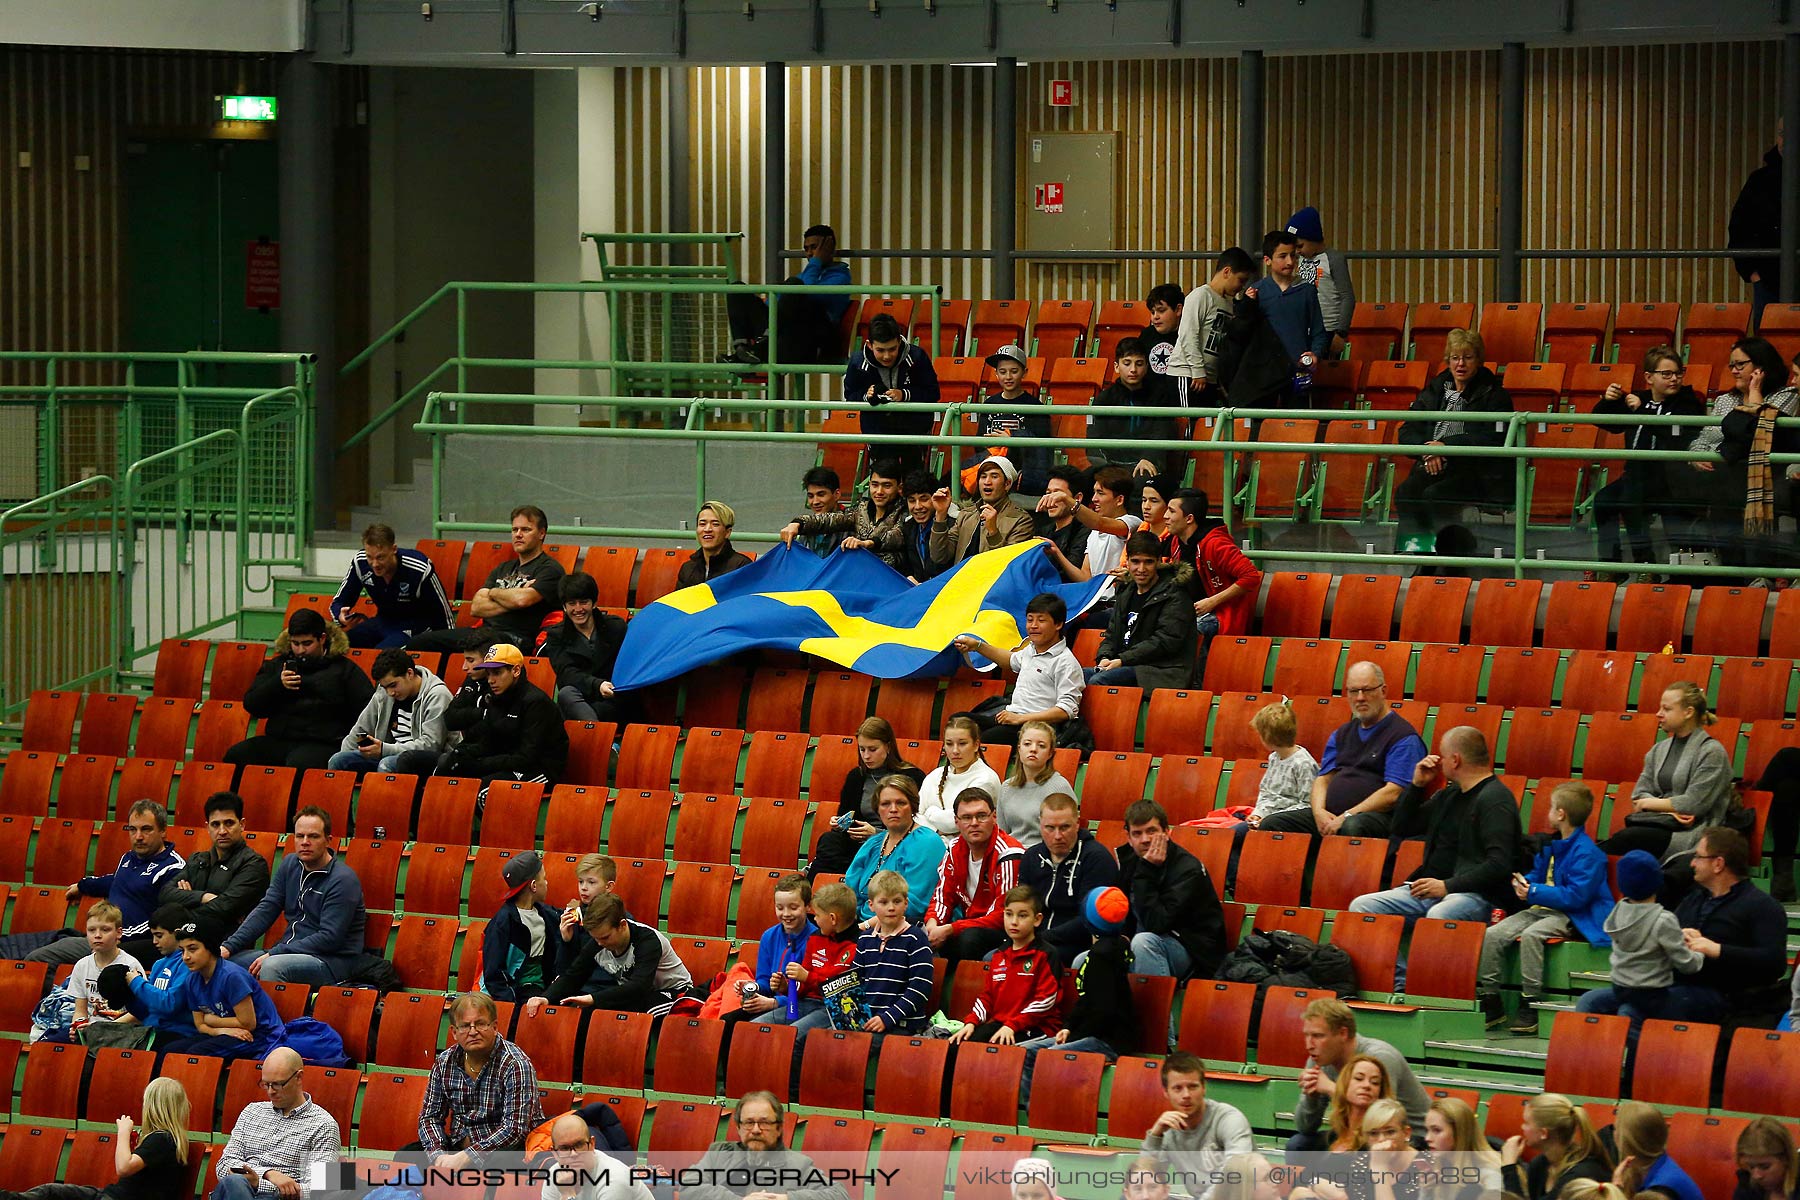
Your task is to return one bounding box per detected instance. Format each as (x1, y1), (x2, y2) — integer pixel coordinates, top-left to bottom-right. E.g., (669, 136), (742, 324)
(212, 1047), (344, 1200)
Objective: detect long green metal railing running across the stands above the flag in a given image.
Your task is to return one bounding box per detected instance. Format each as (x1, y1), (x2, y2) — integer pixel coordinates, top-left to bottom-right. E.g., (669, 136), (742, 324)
(414, 392), (1800, 579)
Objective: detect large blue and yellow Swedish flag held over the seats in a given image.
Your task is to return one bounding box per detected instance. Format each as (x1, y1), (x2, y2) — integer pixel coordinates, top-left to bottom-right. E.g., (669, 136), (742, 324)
(612, 542), (1105, 689)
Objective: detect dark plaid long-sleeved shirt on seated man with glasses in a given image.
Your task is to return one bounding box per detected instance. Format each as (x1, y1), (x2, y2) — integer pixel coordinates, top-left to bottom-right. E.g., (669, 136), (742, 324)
(419, 1038), (544, 1166)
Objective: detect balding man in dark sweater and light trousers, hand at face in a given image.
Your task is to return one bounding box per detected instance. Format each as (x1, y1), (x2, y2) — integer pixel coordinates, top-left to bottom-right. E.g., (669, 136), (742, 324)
(1350, 725), (1519, 990)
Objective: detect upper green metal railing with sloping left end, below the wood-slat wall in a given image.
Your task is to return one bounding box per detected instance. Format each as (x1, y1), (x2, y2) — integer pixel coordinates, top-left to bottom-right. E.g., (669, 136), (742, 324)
(338, 278), (943, 453)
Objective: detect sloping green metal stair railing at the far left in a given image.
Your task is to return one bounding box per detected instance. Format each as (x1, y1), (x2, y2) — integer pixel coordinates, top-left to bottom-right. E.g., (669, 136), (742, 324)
(0, 387), (311, 720)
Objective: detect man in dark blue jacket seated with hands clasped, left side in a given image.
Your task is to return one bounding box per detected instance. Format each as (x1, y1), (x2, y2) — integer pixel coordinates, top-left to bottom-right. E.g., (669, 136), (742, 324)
(223, 804), (369, 984)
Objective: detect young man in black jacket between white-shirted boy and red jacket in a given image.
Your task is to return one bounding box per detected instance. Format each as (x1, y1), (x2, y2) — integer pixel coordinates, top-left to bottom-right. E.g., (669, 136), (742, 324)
(1084, 529), (1197, 691)
